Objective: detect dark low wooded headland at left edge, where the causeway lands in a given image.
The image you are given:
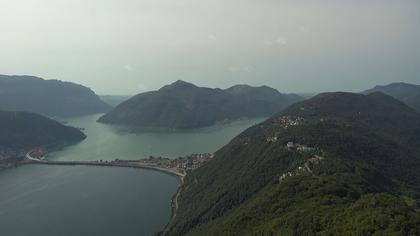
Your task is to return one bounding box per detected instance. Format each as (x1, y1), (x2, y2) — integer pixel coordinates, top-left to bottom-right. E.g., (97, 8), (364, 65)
(0, 111), (86, 160)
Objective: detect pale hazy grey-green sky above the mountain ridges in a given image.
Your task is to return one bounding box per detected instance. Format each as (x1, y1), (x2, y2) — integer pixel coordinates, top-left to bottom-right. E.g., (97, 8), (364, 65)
(0, 0), (420, 94)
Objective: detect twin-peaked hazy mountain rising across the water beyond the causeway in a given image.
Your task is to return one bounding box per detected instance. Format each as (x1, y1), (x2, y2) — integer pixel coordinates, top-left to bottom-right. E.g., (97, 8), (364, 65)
(99, 81), (301, 129)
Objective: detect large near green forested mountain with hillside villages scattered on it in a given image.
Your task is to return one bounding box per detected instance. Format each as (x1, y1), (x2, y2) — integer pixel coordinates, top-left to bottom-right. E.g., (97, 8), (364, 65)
(168, 93), (420, 235)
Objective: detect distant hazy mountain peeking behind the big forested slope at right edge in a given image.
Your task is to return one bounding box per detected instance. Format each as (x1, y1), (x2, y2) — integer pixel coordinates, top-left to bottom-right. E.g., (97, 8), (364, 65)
(363, 83), (420, 111)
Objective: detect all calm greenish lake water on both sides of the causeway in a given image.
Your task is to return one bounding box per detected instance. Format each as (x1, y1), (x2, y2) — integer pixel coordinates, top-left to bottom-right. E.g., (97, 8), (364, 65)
(0, 115), (263, 236)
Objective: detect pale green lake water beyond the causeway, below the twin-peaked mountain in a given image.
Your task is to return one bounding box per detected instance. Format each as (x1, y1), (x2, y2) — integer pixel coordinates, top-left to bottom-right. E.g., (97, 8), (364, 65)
(48, 115), (264, 160)
